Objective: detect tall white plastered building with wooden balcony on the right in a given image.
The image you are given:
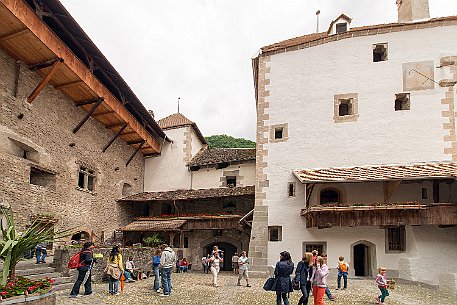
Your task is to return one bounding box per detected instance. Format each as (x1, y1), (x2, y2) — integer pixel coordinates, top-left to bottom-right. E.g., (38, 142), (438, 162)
(250, 0), (457, 290)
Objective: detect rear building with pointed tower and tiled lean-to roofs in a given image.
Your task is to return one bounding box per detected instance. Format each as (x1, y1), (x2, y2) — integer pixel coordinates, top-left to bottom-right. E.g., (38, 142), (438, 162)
(119, 113), (255, 270)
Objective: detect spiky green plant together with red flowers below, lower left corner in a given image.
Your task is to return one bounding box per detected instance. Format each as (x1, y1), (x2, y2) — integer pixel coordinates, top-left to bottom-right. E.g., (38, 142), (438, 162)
(0, 206), (70, 299)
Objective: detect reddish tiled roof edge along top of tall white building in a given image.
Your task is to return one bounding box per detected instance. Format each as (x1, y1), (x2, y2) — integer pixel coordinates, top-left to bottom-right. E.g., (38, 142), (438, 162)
(261, 16), (457, 53)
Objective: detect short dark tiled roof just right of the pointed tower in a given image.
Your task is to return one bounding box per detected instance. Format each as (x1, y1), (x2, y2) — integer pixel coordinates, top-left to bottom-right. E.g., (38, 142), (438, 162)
(189, 148), (255, 166)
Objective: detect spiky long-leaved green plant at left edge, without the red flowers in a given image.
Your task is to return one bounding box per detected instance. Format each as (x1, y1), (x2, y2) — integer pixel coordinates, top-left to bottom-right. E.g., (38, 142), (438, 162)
(0, 206), (71, 286)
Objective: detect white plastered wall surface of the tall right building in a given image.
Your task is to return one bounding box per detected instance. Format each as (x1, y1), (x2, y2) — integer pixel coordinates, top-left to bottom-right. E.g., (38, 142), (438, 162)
(264, 26), (457, 283)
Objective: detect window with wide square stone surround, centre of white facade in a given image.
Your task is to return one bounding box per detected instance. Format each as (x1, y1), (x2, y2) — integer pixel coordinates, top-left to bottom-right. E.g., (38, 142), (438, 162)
(333, 93), (359, 123)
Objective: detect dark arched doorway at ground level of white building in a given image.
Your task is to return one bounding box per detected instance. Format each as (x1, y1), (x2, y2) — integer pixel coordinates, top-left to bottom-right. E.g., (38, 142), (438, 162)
(351, 240), (376, 276)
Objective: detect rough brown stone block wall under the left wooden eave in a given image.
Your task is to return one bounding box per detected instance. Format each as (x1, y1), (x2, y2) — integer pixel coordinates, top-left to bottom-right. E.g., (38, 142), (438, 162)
(0, 51), (144, 241)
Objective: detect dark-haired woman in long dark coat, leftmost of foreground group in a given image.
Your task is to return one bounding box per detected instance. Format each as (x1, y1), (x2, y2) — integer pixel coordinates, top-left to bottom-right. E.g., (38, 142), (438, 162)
(274, 251), (294, 305)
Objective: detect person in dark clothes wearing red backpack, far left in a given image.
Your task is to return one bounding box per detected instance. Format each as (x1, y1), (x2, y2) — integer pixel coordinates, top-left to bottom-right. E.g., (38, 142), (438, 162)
(68, 242), (97, 298)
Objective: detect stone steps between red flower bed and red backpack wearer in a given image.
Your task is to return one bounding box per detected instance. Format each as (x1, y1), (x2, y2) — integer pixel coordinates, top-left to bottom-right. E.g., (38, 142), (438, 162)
(12, 256), (74, 290)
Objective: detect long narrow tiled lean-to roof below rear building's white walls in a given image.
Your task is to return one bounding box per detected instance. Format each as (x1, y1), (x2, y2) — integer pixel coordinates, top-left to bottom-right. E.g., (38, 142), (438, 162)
(118, 186), (254, 202)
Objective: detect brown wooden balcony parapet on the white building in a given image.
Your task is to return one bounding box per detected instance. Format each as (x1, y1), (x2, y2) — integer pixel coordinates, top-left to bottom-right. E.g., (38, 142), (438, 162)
(301, 203), (457, 228)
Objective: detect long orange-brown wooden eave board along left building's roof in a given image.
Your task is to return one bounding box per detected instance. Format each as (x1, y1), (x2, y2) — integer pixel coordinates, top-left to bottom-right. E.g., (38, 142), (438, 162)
(0, 0), (160, 153)
